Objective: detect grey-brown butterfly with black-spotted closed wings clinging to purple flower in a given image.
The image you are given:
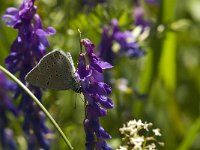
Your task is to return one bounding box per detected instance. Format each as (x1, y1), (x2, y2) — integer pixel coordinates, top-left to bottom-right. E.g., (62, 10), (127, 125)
(25, 50), (81, 93)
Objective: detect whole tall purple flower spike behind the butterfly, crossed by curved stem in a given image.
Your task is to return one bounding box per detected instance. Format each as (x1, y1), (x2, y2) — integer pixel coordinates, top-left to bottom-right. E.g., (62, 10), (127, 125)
(2, 0), (55, 150)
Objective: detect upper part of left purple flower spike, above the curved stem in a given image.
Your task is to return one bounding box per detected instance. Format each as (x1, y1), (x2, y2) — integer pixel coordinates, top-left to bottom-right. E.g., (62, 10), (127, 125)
(2, 0), (55, 74)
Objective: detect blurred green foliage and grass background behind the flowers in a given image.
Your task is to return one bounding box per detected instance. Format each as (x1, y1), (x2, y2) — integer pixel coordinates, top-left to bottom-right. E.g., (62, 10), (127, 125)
(0, 0), (200, 150)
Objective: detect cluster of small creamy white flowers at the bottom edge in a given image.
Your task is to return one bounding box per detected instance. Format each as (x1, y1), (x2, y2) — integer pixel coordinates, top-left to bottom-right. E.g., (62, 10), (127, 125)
(117, 119), (164, 150)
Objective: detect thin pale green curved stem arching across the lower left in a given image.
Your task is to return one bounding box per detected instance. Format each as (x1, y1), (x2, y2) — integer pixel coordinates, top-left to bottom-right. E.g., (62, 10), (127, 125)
(0, 65), (73, 150)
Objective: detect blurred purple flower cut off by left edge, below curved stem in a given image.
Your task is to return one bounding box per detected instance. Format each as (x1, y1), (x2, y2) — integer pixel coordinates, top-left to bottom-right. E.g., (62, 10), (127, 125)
(0, 72), (18, 150)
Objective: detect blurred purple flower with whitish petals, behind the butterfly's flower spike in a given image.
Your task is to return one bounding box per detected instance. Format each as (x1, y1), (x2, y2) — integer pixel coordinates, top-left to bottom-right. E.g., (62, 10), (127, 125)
(98, 19), (144, 64)
